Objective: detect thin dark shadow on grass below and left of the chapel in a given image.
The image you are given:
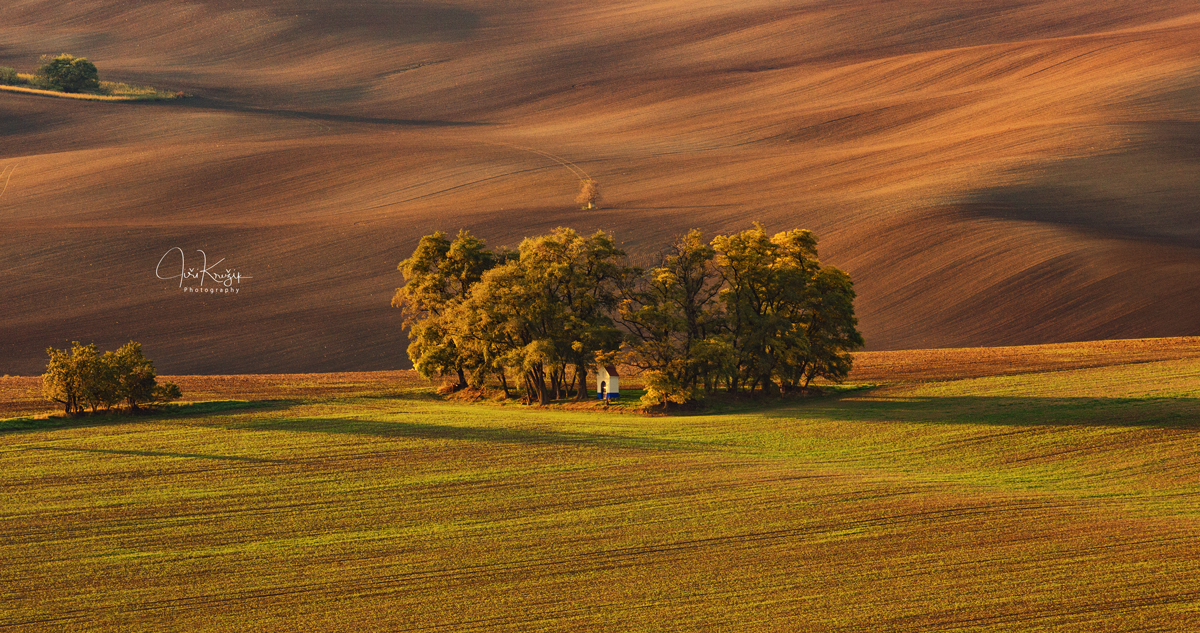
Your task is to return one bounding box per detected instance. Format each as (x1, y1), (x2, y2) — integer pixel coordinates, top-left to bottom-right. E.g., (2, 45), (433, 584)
(230, 417), (712, 451)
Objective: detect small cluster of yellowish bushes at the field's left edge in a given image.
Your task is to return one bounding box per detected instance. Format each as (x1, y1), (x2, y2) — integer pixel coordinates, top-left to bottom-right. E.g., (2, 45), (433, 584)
(42, 340), (182, 415)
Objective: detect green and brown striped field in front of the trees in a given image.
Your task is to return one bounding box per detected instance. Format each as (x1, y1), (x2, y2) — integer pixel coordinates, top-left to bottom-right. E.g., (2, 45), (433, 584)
(0, 339), (1200, 631)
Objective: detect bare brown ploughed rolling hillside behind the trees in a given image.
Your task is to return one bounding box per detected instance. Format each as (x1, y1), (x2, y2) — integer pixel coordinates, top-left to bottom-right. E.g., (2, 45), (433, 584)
(0, 0), (1200, 374)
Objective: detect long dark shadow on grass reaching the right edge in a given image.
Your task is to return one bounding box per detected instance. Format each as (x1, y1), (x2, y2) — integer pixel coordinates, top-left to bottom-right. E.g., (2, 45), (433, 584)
(764, 392), (1200, 429)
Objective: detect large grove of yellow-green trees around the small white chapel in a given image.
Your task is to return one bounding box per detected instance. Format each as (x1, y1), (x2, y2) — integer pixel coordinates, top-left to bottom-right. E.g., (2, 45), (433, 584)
(392, 224), (863, 404)
